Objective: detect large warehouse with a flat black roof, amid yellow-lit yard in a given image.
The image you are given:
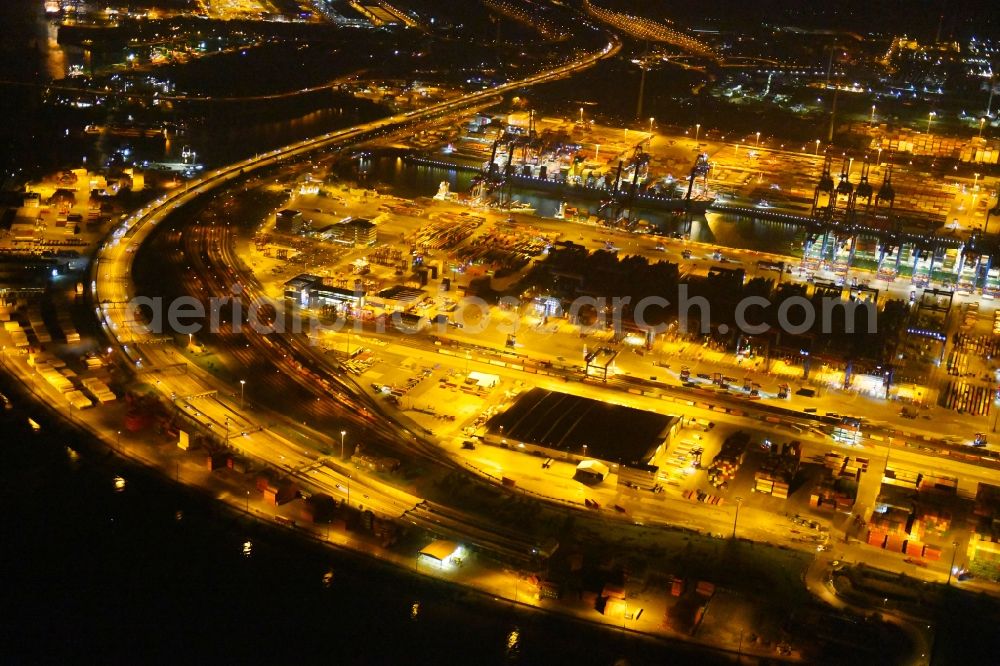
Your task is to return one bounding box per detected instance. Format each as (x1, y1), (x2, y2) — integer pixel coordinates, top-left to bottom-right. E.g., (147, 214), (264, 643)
(483, 388), (680, 467)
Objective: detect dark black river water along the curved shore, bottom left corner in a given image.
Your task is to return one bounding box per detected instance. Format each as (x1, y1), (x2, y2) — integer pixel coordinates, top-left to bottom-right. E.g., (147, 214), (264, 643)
(0, 368), (731, 664)
